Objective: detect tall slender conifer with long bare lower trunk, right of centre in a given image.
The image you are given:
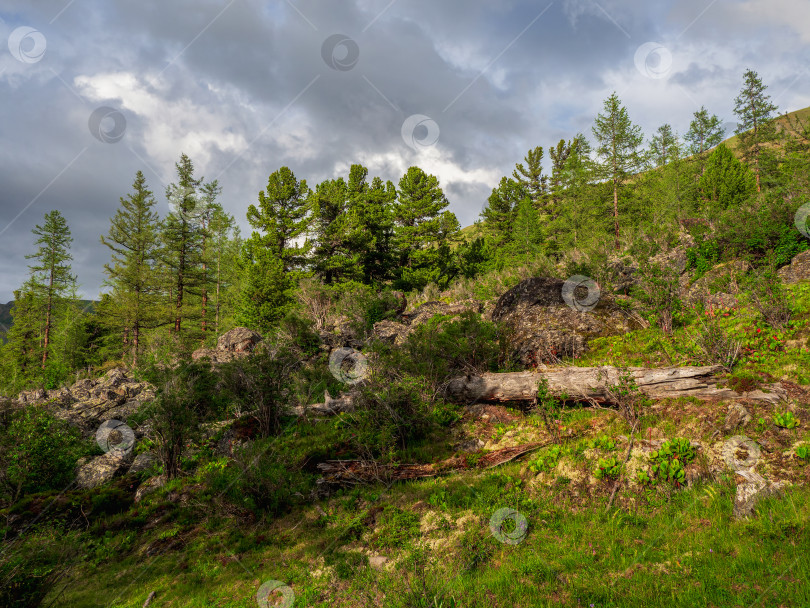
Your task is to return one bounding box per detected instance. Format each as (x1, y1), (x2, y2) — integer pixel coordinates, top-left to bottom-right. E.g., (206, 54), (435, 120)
(593, 92), (644, 249)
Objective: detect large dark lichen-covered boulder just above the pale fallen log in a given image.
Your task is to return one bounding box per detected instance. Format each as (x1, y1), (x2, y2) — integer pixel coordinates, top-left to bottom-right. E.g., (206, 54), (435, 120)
(492, 277), (641, 367)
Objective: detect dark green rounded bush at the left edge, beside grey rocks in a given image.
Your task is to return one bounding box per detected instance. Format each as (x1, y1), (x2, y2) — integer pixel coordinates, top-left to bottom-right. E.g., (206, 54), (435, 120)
(0, 406), (94, 502)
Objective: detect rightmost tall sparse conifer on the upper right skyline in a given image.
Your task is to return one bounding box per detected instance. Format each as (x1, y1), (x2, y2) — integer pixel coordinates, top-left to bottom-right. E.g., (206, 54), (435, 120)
(734, 70), (777, 192)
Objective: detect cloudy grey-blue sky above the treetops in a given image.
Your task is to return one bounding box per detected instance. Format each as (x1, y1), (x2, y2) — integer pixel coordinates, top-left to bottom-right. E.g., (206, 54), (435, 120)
(0, 0), (810, 302)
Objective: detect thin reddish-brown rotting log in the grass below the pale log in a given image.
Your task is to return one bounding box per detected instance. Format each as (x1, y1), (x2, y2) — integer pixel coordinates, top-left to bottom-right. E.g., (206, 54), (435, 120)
(317, 441), (553, 485)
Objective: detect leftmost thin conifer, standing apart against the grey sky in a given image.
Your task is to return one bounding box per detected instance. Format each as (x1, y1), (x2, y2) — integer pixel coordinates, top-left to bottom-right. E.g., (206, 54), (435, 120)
(25, 211), (76, 369)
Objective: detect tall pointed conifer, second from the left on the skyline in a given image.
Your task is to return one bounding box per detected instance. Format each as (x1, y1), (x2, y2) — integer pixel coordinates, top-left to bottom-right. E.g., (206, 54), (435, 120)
(101, 171), (161, 364)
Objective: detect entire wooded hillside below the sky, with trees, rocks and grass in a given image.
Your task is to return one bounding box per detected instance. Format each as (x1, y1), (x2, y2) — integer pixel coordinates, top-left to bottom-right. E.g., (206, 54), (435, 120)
(0, 69), (810, 608)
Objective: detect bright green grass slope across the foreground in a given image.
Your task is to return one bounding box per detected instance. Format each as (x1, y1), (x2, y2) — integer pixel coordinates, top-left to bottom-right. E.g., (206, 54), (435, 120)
(46, 463), (810, 608)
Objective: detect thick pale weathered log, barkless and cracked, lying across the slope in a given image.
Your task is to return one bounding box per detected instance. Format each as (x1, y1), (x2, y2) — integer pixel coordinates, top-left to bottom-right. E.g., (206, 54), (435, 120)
(446, 365), (787, 404)
